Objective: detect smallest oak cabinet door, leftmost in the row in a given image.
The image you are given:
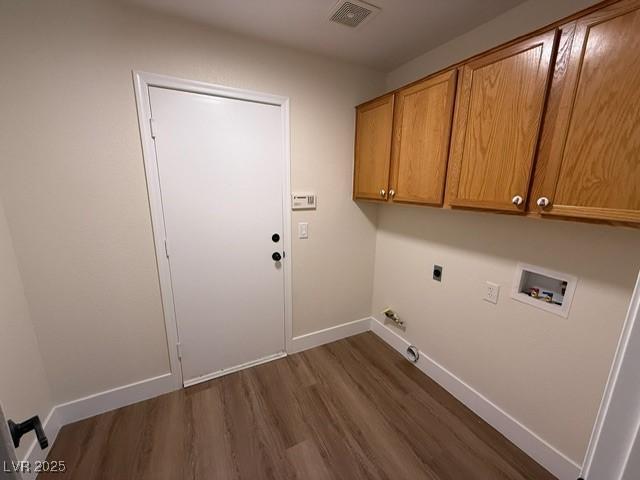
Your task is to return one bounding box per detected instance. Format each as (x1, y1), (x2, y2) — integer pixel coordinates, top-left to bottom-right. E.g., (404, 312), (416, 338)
(353, 94), (393, 201)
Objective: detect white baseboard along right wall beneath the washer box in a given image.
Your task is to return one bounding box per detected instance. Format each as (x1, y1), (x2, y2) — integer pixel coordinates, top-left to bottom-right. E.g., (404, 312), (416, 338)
(371, 318), (580, 480)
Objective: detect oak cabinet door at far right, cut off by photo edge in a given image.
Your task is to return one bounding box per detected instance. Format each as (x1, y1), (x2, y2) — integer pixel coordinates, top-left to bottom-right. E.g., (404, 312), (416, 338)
(532, 0), (640, 222)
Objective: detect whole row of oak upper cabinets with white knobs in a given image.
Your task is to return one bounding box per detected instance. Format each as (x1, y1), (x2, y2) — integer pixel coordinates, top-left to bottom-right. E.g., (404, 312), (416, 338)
(353, 0), (640, 226)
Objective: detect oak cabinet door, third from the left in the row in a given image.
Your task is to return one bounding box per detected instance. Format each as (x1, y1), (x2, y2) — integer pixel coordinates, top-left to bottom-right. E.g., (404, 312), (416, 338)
(448, 30), (556, 212)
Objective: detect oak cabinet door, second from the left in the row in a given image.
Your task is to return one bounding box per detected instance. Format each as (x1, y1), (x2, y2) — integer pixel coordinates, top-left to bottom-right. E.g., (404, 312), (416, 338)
(390, 70), (457, 205)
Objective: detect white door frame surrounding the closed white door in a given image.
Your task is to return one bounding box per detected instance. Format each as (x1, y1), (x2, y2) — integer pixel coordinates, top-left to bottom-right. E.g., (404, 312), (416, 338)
(133, 70), (293, 389)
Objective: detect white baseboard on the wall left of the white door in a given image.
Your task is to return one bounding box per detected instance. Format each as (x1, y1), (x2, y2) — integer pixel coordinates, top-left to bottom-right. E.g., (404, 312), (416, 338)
(55, 373), (176, 425)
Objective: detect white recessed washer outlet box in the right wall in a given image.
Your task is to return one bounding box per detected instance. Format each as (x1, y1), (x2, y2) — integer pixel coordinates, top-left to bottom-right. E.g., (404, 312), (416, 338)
(511, 263), (578, 318)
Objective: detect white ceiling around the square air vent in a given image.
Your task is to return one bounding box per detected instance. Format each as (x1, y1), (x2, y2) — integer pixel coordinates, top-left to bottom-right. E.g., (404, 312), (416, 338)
(128, 0), (524, 71)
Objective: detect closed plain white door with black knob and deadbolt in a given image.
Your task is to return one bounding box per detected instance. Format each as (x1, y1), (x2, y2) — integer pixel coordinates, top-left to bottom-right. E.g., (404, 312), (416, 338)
(149, 87), (285, 385)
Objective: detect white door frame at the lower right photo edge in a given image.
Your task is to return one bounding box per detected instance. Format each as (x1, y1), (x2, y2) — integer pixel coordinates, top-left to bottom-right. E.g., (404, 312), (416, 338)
(581, 274), (640, 480)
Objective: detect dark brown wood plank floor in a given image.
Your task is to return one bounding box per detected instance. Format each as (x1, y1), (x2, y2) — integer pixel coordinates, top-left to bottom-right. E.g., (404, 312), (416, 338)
(38, 333), (555, 480)
